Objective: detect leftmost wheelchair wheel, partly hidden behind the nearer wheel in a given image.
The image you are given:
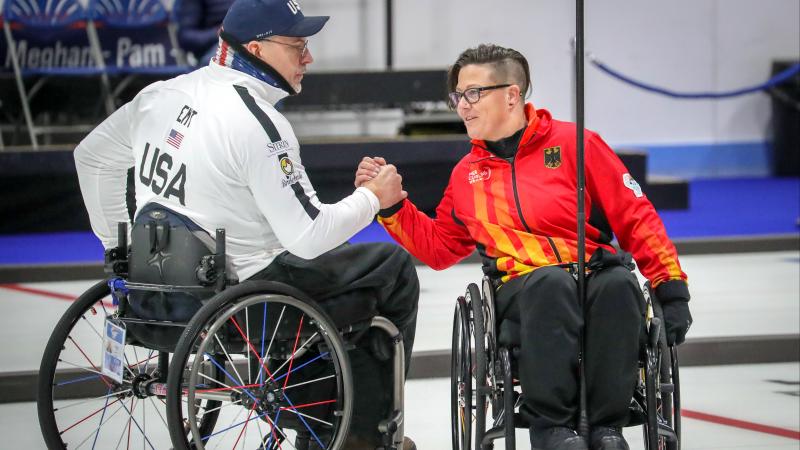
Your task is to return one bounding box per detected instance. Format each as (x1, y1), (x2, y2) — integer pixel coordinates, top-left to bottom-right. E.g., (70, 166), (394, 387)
(37, 281), (219, 449)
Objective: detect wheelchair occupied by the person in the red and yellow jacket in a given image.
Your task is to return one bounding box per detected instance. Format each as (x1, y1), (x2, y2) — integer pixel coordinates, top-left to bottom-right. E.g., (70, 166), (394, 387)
(450, 277), (681, 450)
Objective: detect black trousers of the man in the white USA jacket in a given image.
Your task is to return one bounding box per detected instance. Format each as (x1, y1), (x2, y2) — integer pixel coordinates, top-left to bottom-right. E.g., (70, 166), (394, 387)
(250, 243), (419, 445)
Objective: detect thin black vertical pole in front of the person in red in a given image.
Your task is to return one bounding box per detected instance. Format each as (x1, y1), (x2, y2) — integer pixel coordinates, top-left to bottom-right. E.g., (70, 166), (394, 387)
(575, 0), (589, 437)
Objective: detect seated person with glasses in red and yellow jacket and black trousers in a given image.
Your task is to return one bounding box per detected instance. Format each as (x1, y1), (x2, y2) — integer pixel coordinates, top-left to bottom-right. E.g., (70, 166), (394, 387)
(356, 45), (691, 449)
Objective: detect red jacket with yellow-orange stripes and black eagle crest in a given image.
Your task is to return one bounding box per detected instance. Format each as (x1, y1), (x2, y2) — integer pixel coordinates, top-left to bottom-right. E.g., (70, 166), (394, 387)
(379, 103), (686, 287)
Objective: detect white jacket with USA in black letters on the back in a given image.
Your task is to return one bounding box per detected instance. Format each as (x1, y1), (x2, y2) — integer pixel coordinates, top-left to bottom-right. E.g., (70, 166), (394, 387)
(75, 62), (379, 280)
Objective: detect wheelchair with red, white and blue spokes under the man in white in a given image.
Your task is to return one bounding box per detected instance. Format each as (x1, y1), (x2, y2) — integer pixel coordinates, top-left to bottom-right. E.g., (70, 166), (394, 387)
(37, 205), (405, 450)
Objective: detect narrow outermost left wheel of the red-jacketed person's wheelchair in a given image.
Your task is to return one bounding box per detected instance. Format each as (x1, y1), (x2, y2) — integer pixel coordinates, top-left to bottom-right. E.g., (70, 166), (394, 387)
(450, 297), (473, 450)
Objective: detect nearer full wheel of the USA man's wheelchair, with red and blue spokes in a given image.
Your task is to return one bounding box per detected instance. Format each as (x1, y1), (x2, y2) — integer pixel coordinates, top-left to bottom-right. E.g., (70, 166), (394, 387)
(167, 281), (353, 450)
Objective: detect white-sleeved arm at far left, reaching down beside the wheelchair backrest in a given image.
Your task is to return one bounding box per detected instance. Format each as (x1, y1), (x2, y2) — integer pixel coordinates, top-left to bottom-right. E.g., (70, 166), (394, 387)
(74, 103), (135, 249)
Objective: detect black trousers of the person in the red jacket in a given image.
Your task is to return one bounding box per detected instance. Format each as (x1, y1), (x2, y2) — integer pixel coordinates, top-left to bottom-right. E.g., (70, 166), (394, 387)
(497, 265), (644, 428)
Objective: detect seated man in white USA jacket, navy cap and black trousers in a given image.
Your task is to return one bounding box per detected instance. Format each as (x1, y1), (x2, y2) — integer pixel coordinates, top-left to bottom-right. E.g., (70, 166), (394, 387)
(75, 0), (419, 448)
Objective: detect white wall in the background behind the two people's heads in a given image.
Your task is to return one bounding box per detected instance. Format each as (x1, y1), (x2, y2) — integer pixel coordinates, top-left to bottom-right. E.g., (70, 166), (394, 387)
(302, 0), (800, 145)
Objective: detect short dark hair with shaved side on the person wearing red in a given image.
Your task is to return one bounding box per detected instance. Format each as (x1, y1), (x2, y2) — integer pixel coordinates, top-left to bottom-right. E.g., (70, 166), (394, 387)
(447, 44), (531, 97)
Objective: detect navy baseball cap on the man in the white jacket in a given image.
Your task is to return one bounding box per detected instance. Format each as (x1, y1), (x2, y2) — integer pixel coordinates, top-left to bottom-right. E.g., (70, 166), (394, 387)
(222, 0), (329, 43)
